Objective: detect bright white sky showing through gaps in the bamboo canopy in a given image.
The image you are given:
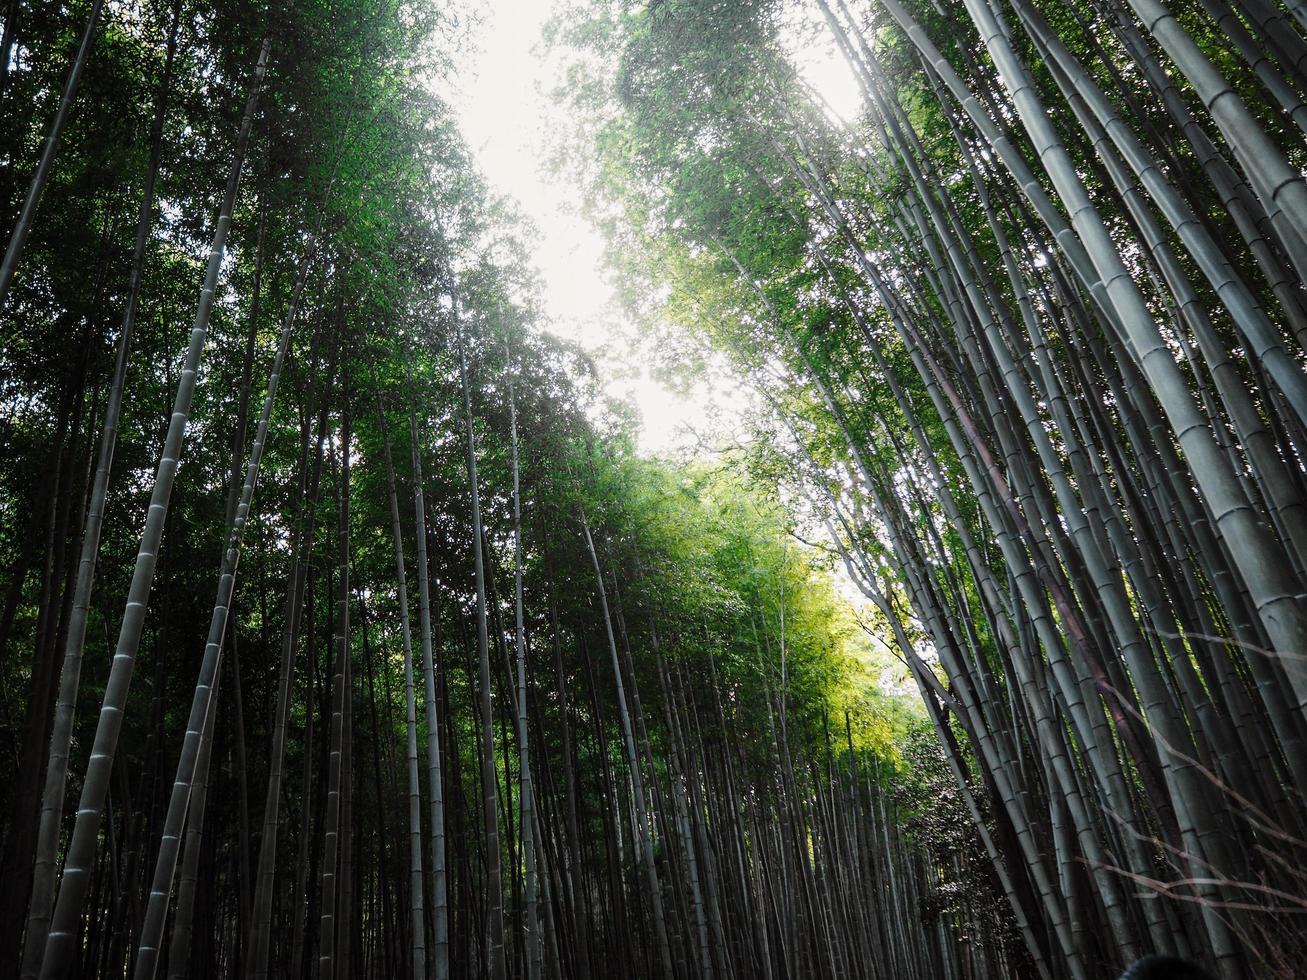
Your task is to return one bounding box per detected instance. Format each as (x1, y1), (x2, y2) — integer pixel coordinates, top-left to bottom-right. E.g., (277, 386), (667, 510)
(452, 0), (859, 453)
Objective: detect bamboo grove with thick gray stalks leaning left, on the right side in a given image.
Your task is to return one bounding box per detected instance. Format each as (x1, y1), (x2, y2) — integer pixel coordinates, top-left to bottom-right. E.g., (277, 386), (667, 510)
(558, 0), (1307, 980)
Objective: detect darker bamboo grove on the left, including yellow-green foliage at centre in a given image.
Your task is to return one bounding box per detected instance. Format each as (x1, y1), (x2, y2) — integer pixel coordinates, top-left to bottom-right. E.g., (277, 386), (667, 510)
(0, 0), (1009, 980)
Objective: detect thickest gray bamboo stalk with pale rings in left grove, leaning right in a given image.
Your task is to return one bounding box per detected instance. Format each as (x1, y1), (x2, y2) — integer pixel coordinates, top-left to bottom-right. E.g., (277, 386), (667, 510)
(41, 38), (272, 980)
